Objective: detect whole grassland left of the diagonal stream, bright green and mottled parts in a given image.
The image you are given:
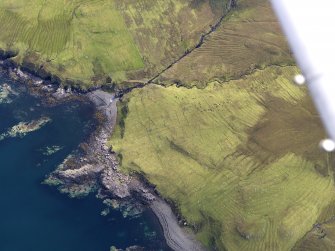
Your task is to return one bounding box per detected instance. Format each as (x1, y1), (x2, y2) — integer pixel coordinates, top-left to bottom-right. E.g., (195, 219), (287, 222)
(0, 0), (225, 89)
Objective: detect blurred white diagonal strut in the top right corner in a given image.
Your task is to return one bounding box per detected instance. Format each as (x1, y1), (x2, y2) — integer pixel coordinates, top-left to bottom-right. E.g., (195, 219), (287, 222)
(271, 0), (335, 143)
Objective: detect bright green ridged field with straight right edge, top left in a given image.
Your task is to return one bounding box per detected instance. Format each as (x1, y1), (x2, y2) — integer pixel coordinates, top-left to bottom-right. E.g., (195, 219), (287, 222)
(0, 0), (144, 88)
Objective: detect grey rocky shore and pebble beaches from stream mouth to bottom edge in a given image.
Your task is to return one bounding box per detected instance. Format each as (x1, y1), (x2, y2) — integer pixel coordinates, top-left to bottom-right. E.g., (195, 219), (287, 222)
(49, 90), (204, 251)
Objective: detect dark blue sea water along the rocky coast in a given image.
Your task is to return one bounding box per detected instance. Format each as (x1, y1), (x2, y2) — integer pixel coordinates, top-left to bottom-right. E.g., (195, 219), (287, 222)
(0, 75), (167, 251)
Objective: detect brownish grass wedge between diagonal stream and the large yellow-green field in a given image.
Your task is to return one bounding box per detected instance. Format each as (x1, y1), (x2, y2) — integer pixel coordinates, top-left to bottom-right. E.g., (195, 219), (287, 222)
(160, 0), (292, 87)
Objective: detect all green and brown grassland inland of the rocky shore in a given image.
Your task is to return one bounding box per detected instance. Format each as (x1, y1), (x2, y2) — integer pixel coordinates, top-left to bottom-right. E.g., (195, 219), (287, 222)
(0, 0), (335, 251)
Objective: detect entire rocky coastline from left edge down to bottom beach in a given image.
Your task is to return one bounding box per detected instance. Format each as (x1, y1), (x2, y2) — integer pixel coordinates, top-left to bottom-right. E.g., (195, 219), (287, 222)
(0, 58), (205, 251)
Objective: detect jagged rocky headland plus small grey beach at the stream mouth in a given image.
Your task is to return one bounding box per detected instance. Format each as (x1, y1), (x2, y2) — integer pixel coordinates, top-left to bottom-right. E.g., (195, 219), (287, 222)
(46, 90), (155, 204)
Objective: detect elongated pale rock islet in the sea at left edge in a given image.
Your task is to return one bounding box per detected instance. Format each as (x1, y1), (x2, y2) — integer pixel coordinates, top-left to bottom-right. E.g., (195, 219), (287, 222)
(0, 117), (51, 140)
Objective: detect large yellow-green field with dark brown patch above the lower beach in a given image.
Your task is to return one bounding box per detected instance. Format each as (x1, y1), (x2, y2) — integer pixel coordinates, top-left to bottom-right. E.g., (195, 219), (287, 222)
(111, 67), (335, 250)
